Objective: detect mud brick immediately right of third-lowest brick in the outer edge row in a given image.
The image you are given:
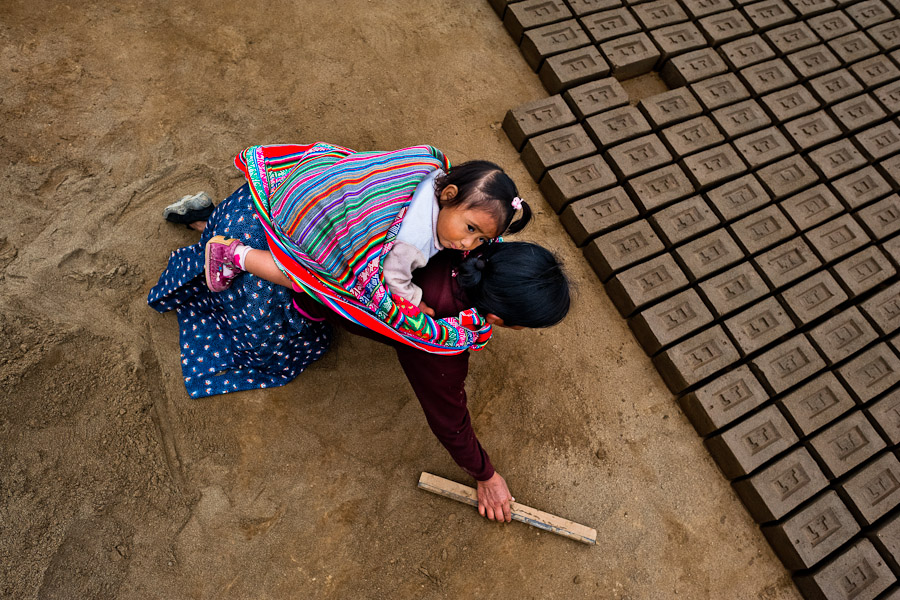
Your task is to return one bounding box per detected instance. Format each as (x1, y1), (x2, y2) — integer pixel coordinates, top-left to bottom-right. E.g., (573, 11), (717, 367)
(809, 410), (885, 478)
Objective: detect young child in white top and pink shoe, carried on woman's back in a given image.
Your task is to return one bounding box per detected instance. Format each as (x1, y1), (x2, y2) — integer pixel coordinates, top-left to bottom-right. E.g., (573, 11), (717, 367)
(206, 160), (532, 317)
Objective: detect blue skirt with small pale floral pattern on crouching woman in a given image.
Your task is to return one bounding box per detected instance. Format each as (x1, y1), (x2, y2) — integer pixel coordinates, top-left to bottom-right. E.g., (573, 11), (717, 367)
(147, 185), (332, 398)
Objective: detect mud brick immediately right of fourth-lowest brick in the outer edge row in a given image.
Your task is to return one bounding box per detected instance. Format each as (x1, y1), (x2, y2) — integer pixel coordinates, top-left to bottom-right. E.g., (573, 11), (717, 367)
(779, 371), (856, 436)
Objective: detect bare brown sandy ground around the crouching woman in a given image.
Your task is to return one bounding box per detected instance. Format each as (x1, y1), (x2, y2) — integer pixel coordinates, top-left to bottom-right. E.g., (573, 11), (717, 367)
(0, 0), (797, 600)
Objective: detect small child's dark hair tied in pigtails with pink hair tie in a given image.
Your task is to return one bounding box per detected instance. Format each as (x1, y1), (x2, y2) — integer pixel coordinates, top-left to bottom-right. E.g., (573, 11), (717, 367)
(435, 160), (531, 235)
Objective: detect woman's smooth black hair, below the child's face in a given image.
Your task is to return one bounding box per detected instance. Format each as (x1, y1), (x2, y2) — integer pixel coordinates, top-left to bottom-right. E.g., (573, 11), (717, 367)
(457, 242), (569, 327)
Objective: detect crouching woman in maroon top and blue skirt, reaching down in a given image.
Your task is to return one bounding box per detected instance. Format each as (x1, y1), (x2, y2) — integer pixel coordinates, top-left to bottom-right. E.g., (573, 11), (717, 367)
(148, 185), (569, 521)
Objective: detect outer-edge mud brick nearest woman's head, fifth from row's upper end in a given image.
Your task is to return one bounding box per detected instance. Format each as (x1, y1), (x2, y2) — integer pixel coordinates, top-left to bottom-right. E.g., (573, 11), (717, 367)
(584, 220), (665, 281)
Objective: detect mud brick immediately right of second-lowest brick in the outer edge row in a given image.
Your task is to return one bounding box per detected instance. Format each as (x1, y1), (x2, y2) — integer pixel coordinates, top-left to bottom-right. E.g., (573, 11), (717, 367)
(840, 453), (900, 525)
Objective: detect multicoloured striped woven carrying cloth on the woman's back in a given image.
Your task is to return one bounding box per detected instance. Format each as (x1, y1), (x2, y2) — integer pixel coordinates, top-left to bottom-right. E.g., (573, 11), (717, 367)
(235, 142), (491, 354)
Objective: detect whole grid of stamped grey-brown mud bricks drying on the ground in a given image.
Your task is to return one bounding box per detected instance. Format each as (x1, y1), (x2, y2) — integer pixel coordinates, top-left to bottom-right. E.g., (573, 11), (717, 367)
(491, 0), (900, 600)
